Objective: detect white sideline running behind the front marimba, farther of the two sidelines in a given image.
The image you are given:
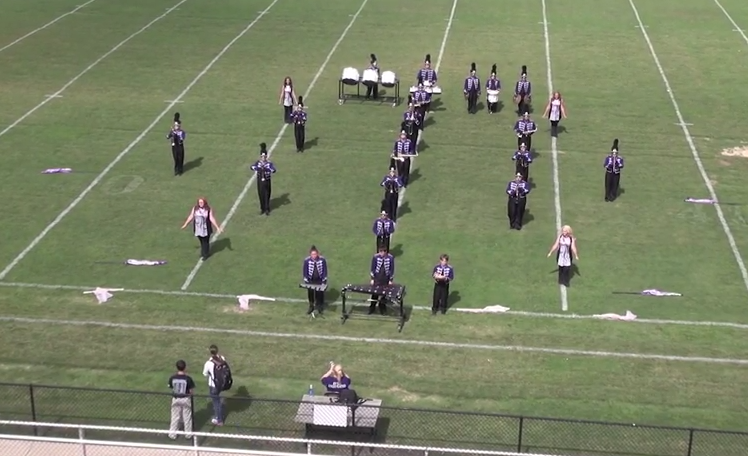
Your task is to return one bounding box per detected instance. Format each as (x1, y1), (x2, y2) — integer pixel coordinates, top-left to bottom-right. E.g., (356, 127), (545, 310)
(0, 282), (748, 330)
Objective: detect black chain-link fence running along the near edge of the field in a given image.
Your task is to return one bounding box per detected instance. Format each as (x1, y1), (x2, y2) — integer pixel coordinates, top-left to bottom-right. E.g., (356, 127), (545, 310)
(0, 383), (748, 456)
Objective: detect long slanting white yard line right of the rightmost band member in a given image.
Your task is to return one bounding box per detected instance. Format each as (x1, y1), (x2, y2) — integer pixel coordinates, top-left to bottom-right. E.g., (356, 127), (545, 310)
(629, 0), (748, 289)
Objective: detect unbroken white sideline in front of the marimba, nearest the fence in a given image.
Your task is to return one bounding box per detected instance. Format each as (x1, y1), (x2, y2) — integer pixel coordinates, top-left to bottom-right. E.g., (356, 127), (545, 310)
(0, 317), (748, 366)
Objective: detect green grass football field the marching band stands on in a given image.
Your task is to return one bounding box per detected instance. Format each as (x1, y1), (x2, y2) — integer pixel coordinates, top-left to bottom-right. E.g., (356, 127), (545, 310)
(0, 0), (748, 454)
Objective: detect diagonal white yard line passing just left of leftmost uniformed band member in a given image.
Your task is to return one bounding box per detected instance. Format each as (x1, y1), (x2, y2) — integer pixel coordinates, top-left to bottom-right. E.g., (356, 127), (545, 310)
(0, 0), (279, 280)
